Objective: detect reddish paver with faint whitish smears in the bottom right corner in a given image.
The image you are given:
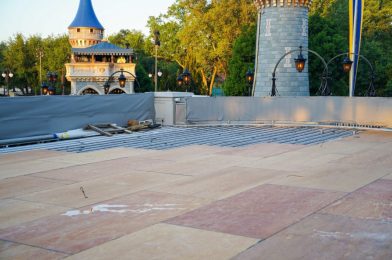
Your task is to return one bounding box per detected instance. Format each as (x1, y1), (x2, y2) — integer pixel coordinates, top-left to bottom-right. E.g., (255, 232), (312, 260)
(234, 214), (392, 260)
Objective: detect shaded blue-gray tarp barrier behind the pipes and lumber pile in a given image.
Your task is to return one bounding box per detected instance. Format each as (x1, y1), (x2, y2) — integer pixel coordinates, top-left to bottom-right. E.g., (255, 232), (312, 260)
(0, 93), (155, 140)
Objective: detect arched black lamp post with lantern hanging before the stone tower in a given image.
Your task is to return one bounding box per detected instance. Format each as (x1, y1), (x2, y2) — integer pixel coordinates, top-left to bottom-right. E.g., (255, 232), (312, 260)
(271, 46), (328, 96)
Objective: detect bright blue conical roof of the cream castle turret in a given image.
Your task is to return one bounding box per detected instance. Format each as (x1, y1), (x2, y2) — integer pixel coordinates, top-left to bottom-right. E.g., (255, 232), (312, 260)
(68, 0), (104, 30)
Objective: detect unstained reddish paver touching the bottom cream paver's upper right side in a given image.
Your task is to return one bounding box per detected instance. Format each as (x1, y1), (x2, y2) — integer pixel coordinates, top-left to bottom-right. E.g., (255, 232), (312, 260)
(167, 185), (344, 239)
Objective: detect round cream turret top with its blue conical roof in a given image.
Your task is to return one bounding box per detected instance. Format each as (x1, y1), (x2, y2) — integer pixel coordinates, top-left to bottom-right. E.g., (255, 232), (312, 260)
(68, 0), (105, 48)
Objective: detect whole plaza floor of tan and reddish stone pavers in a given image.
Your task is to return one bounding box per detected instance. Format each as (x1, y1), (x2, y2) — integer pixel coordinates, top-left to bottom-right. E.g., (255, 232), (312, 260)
(0, 128), (392, 260)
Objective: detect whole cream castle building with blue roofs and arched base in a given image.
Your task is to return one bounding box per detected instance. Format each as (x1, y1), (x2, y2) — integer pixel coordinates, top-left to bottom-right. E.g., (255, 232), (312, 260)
(65, 0), (136, 95)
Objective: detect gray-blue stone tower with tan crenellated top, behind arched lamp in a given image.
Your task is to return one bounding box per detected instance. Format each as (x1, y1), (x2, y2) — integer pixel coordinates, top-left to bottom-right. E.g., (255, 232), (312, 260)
(254, 0), (312, 97)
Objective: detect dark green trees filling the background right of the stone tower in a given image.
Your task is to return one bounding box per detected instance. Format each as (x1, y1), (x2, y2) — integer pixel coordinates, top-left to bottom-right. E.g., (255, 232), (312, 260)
(309, 0), (392, 96)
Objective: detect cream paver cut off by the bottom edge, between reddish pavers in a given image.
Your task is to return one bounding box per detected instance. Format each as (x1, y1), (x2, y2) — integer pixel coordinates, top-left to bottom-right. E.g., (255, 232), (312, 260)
(69, 224), (257, 260)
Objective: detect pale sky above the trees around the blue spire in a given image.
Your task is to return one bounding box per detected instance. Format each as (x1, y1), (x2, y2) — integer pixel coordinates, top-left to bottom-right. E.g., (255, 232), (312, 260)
(0, 0), (175, 41)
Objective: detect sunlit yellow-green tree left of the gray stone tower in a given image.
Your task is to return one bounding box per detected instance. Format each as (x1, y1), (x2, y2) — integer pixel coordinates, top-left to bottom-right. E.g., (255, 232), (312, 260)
(149, 0), (256, 94)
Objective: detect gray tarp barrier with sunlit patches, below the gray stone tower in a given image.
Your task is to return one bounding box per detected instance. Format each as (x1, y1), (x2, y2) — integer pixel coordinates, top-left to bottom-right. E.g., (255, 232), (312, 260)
(186, 97), (392, 127)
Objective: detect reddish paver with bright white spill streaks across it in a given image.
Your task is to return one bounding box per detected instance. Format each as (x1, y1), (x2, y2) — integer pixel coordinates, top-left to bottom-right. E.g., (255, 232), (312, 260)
(0, 192), (208, 253)
